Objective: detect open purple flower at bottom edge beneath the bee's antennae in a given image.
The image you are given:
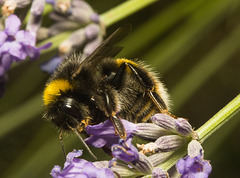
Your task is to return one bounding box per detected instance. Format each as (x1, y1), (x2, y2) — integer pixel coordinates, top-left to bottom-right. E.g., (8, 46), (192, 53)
(51, 150), (114, 178)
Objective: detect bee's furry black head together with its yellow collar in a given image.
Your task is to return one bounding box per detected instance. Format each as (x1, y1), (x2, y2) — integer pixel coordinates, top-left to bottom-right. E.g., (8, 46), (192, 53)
(43, 79), (90, 131)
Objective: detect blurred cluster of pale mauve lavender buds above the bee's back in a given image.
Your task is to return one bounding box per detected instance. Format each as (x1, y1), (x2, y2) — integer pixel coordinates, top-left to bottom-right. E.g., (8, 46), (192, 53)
(39, 0), (102, 74)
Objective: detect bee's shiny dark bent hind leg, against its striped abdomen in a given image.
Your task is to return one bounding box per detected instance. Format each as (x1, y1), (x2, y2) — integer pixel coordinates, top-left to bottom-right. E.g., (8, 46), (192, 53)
(126, 63), (168, 113)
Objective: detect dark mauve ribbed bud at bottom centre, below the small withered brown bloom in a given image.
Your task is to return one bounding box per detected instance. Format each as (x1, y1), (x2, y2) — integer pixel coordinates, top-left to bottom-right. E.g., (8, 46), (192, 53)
(130, 153), (153, 174)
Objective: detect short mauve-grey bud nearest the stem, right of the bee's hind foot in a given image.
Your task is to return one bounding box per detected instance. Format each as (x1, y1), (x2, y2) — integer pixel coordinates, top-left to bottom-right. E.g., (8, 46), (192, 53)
(174, 118), (193, 136)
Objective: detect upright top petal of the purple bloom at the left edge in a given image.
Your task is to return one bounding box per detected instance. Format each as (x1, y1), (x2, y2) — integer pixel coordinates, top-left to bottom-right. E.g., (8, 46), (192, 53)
(5, 14), (21, 35)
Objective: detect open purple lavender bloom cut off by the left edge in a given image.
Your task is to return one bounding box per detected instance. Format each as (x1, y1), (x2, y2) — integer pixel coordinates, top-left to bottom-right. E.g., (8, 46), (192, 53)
(0, 14), (51, 96)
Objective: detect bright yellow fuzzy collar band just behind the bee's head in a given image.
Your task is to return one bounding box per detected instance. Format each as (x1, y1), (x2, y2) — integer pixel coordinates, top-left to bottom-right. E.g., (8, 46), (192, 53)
(43, 79), (73, 105)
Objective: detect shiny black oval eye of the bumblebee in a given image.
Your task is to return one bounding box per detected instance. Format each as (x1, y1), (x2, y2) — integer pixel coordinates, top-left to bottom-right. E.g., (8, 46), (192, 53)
(61, 98), (81, 119)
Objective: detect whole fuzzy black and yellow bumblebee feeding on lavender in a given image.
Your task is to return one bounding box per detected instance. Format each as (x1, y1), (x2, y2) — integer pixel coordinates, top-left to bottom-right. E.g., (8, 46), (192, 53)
(43, 25), (169, 153)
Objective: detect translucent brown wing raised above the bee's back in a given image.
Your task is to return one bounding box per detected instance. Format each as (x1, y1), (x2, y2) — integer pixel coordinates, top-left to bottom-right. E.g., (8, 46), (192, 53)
(72, 24), (131, 78)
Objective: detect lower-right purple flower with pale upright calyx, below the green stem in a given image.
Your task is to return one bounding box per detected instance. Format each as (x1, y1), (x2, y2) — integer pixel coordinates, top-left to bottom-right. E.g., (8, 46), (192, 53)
(176, 140), (212, 178)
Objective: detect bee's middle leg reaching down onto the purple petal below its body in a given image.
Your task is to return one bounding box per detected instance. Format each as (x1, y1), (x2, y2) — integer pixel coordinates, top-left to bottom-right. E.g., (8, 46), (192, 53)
(104, 92), (127, 139)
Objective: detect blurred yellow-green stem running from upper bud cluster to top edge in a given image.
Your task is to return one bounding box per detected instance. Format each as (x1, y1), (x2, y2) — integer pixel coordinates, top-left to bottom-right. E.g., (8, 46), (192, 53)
(100, 0), (157, 27)
